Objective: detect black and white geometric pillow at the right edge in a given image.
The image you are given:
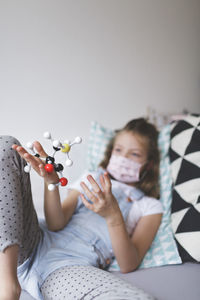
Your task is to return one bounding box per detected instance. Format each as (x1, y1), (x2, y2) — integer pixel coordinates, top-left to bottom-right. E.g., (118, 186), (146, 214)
(169, 115), (200, 262)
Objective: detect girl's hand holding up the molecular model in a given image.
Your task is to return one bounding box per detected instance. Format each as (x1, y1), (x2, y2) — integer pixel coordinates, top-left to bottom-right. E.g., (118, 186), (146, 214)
(12, 141), (59, 184)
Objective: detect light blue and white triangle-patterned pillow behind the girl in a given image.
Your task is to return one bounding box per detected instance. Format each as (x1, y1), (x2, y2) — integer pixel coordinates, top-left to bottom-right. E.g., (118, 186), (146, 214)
(87, 122), (181, 271)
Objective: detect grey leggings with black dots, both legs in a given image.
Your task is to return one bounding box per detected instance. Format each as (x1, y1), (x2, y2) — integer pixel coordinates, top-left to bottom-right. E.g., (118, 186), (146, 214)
(0, 136), (153, 300)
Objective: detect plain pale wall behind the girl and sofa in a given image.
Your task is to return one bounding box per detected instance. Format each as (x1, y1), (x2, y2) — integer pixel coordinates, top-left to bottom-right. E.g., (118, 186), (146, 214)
(0, 0), (200, 216)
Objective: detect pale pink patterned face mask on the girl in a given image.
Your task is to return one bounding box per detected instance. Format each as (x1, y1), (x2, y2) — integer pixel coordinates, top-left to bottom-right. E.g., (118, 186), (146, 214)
(107, 155), (142, 183)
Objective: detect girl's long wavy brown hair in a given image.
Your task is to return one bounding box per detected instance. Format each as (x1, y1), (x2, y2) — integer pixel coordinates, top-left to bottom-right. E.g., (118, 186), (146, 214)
(99, 118), (160, 198)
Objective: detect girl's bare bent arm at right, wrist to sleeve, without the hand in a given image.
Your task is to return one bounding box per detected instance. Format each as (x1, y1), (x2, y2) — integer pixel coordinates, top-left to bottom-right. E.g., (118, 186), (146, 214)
(105, 214), (162, 273)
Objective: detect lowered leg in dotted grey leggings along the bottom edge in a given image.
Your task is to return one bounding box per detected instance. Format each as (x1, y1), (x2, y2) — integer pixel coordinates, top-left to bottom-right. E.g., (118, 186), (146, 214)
(41, 266), (154, 300)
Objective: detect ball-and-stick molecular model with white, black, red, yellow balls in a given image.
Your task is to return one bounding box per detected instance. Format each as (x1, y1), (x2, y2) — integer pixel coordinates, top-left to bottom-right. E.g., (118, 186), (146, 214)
(24, 132), (82, 191)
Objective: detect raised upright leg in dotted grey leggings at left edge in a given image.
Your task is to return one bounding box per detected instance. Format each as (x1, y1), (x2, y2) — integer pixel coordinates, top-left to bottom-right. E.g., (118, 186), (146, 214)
(0, 136), (40, 265)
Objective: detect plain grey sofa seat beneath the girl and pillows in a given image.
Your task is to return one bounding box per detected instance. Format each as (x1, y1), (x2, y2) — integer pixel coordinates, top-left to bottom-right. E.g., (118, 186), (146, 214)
(20, 262), (200, 300)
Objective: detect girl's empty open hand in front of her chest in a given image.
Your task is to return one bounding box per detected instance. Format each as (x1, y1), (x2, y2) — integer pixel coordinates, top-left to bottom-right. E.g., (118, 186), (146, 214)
(81, 173), (121, 221)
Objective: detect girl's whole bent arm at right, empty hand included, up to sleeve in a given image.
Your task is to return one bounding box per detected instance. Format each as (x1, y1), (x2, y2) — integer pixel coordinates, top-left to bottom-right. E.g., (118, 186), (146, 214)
(81, 173), (162, 273)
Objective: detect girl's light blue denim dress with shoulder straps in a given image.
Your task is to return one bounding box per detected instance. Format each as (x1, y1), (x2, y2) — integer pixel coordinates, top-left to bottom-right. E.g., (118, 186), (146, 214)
(18, 168), (144, 300)
